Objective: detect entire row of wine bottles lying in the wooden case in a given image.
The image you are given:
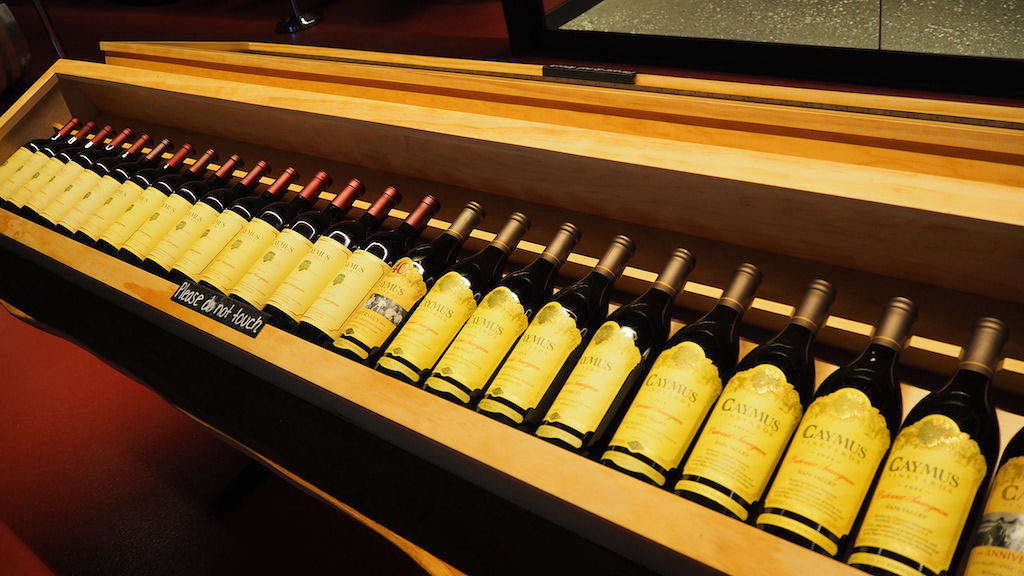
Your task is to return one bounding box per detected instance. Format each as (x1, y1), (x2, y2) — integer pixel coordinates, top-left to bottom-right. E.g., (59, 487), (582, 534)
(0, 119), (1024, 574)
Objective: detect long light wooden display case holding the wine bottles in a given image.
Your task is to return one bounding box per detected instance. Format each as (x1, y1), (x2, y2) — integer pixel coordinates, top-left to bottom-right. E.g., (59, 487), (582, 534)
(0, 43), (1024, 575)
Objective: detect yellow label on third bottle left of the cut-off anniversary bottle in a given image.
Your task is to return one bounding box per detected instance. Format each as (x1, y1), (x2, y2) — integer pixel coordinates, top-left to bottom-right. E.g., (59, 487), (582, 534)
(676, 364), (803, 521)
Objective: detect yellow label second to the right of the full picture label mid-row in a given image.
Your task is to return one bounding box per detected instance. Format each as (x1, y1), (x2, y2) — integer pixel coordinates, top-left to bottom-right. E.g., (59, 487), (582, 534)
(427, 286), (529, 403)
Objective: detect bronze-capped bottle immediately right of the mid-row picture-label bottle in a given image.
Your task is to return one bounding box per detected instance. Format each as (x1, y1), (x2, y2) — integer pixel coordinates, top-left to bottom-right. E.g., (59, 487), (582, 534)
(376, 212), (529, 384)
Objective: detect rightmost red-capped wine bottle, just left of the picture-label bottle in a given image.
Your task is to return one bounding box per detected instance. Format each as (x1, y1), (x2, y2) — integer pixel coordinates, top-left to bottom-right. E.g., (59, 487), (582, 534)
(293, 196), (440, 347)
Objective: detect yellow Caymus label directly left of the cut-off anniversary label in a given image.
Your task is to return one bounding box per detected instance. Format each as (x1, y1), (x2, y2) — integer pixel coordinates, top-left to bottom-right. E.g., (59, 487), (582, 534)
(849, 414), (988, 573)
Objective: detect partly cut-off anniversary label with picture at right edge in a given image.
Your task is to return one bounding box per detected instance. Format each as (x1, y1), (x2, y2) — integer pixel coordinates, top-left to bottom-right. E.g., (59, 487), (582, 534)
(964, 456), (1024, 576)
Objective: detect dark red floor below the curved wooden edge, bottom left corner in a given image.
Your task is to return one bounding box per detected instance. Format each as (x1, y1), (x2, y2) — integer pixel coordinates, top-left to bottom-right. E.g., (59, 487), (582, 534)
(0, 312), (422, 576)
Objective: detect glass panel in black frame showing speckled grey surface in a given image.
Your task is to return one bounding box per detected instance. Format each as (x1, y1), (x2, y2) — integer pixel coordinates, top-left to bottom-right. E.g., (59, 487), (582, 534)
(543, 0), (1024, 58)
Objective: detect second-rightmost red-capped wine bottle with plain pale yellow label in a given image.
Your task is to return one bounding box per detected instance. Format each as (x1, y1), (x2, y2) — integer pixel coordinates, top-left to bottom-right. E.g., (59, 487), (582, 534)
(263, 187), (401, 330)
